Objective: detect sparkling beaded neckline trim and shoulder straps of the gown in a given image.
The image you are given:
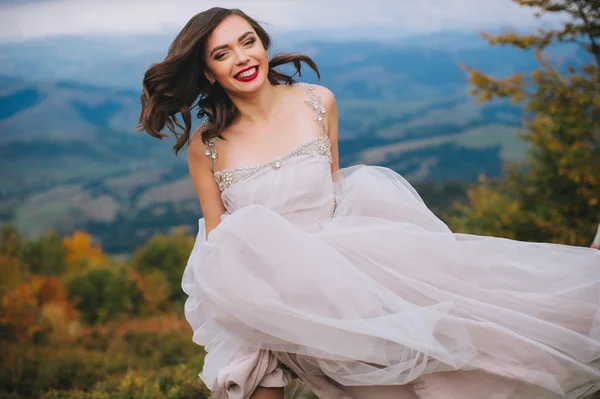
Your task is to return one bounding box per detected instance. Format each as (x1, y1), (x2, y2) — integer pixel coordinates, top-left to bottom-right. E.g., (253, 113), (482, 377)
(205, 83), (332, 191)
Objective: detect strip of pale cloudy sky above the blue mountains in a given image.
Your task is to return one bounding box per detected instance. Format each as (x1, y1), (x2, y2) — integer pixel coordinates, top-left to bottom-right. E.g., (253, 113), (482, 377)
(0, 0), (564, 41)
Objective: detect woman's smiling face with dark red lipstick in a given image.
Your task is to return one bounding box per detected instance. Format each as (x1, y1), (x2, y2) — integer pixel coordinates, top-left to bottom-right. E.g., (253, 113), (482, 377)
(204, 15), (269, 94)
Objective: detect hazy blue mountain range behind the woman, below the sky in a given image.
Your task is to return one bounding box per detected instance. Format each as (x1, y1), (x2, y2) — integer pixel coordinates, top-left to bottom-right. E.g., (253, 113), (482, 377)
(0, 33), (581, 252)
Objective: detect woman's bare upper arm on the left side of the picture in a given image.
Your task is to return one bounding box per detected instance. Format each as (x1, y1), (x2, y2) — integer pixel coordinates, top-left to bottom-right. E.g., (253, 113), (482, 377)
(188, 132), (226, 239)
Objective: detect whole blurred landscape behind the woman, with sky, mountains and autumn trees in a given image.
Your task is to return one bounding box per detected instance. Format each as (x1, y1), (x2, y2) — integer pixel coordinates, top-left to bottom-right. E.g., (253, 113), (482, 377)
(0, 0), (600, 398)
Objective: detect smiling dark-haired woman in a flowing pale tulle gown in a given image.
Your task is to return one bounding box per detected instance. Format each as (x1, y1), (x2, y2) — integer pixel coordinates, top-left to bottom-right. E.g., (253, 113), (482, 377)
(140, 8), (600, 399)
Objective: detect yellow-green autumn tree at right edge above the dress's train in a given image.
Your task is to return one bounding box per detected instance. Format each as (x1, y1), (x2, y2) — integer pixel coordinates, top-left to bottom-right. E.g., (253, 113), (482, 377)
(455, 0), (600, 246)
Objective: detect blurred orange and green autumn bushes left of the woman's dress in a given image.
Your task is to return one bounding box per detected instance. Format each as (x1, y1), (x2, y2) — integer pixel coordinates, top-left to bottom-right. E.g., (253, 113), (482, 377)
(0, 225), (209, 399)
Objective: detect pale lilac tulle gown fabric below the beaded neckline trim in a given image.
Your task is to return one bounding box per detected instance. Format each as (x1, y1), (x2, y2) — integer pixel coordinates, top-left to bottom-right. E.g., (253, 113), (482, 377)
(183, 151), (600, 399)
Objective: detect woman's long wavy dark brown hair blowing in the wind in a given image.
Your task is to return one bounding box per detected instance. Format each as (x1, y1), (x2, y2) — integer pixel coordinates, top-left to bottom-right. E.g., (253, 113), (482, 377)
(138, 7), (321, 154)
